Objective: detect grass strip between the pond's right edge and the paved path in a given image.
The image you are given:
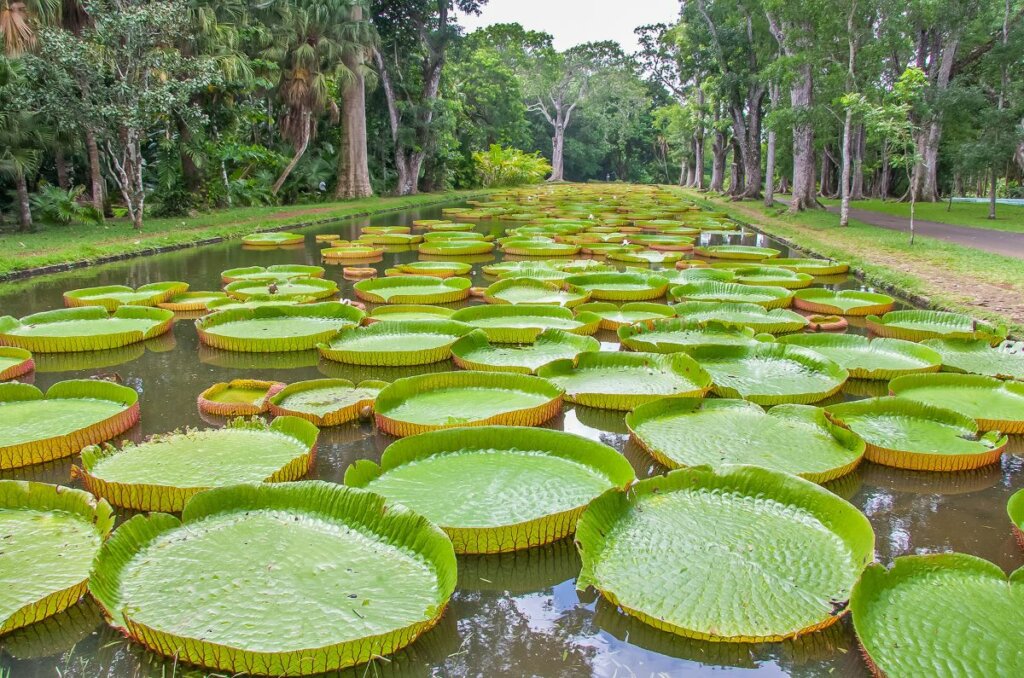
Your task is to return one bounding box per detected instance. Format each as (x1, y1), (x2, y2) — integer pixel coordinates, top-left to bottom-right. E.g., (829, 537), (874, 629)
(684, 189), (1024, 336)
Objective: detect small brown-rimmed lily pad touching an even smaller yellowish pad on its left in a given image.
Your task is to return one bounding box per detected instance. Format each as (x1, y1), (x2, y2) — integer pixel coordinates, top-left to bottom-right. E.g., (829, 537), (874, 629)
(268, 379), (388, 426)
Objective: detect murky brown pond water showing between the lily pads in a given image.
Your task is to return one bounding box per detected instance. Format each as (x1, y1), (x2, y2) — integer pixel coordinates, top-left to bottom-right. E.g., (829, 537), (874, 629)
(0, 202), (1024, 678)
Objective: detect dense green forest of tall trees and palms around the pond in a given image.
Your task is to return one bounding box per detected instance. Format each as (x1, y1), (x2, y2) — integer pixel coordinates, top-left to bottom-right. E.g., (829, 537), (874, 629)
(0, 0), (1024, 229)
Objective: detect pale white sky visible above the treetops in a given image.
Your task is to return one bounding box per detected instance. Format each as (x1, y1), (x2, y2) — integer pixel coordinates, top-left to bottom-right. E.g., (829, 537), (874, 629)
(459, 0), (679, 52)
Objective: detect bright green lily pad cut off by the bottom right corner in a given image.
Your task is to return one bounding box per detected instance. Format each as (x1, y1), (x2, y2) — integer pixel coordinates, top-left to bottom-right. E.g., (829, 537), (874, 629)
(850, 553), (1024, 676)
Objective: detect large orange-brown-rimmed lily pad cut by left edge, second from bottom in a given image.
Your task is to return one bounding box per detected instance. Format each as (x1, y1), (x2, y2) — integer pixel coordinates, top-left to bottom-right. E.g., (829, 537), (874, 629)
(0, 379), (138, 469)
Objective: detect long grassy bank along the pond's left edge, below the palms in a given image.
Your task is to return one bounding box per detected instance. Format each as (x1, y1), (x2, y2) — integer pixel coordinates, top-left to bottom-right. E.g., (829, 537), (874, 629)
(0, 190), (484, 277)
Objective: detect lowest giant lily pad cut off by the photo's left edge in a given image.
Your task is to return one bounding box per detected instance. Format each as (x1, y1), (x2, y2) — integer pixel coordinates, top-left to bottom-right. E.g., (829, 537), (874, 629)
(0, 480), (114, 635)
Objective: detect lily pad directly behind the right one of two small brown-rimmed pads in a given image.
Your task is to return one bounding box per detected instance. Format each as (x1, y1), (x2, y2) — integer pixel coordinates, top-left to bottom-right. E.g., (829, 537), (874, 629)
(316, 320), (473, 367)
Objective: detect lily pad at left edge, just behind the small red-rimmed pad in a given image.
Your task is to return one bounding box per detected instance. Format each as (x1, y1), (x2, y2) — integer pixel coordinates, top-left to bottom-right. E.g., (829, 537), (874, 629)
(0, 306), (174, 353)
